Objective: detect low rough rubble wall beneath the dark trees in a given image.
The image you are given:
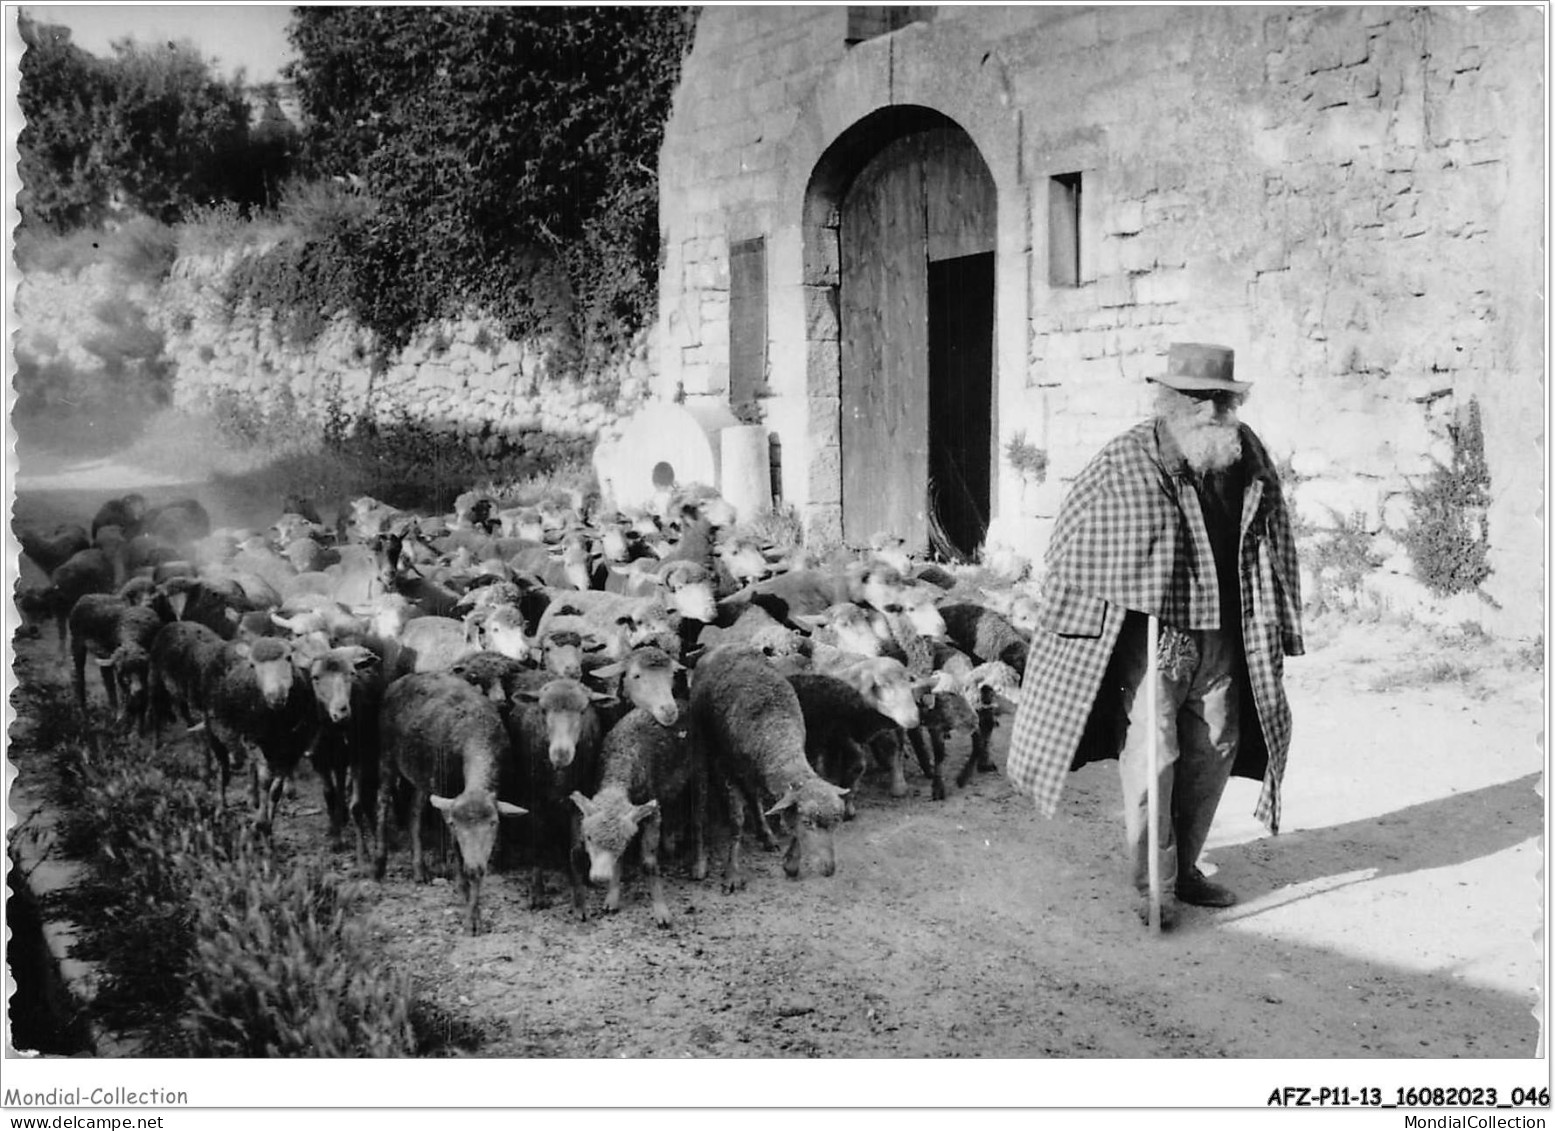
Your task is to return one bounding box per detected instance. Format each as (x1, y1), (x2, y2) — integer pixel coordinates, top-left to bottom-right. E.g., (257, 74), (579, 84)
(16, 254), (648, 456)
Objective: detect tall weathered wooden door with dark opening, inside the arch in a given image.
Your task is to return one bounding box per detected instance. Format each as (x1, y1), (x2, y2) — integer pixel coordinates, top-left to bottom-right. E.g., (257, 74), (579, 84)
(838, 128), (994, 551)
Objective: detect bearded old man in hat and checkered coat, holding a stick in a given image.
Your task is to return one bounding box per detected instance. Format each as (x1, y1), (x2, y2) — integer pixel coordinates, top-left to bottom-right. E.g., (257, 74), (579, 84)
(1006, 342), (1303, 926)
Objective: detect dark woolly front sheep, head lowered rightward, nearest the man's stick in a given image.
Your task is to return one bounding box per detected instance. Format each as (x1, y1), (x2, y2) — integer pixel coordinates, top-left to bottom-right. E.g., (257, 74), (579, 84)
(690, 644), (843, 891)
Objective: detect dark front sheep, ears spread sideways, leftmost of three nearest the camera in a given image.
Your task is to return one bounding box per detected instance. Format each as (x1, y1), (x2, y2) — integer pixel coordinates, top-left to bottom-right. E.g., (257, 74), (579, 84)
(373, 672), (526, 935)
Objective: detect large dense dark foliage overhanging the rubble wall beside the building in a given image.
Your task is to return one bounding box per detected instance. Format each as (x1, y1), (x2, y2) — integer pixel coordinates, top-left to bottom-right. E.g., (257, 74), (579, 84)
(289, 6), (690, 370)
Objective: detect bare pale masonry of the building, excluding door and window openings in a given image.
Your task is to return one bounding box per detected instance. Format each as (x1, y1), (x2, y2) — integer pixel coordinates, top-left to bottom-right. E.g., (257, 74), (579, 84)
(655, 5), (1544, 635)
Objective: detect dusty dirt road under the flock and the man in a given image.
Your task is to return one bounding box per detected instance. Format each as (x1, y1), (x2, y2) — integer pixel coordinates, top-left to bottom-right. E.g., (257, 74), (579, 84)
(6, 448), (1546, 1058)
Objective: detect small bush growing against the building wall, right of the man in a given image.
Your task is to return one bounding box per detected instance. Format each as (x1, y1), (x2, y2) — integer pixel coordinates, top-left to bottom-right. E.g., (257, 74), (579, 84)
(1400, 400), (1490, 596)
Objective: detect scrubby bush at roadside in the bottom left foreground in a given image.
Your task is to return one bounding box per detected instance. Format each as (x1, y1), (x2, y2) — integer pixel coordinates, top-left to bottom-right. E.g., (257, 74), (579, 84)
(48, 721), (415, 1056)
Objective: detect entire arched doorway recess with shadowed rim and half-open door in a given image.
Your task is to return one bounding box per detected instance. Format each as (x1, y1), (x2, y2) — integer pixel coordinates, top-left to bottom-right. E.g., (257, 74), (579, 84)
(804, 106), (997, 557)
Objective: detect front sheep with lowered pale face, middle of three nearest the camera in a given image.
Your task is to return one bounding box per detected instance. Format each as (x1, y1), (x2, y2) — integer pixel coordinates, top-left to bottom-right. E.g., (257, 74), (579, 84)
(572, 708), (708, 927)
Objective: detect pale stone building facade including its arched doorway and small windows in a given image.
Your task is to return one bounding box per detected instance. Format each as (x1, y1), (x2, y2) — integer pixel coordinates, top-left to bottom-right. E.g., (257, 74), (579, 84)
(652, 5), (1546, 635)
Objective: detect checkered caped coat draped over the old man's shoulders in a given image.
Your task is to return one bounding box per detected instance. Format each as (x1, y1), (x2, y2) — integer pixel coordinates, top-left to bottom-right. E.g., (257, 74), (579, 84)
(1006, 422), (1303, 832)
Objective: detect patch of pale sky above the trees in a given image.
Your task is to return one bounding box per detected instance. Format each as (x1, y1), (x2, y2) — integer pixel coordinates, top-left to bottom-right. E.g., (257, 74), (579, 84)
(21, 3), (294, 82)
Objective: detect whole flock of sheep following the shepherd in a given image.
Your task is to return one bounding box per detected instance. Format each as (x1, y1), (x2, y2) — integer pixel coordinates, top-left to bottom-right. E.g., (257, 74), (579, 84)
(17, 492), (1033, 933)
